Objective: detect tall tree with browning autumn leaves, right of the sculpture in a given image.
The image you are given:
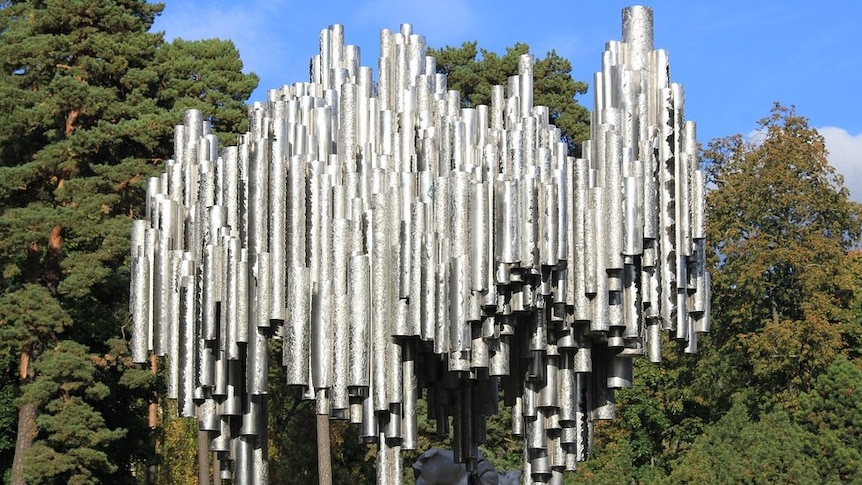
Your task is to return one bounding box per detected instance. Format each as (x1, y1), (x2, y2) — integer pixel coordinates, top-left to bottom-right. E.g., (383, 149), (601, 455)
(703, 104), (862, 406)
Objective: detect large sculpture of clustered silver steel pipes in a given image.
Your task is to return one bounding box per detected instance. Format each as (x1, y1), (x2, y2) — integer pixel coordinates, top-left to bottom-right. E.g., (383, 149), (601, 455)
(130, 7), (709, 484)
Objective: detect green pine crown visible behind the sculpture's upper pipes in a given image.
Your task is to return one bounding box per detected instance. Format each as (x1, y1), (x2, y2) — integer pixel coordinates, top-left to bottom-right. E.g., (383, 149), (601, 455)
(428, 41), (590, 155)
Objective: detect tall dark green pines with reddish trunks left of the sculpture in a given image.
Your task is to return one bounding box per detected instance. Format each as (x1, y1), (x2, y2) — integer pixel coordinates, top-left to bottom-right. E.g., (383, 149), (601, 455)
(0, 0), (257, 483)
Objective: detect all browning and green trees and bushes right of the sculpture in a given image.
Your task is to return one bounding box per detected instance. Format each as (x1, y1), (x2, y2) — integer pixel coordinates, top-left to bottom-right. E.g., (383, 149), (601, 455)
(578, 104), (862, 483)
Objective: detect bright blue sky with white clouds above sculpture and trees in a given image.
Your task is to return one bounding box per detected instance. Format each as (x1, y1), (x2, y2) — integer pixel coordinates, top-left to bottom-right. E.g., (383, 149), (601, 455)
(154, 0), (862, 201)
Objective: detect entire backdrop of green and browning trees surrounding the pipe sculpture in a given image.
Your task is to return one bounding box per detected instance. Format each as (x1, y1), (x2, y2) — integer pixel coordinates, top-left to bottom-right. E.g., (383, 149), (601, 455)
(0, 0), (862, 484)
